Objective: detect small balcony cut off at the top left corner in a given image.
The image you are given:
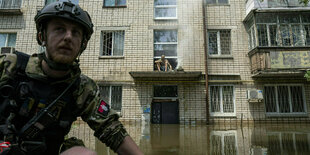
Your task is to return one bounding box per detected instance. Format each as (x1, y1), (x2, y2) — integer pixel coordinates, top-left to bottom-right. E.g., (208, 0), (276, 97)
(0, 0), (22, 15)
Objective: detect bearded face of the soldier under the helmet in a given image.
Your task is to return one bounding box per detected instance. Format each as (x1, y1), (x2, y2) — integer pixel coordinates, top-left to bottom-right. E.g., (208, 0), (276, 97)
(46, 18), (83, 64)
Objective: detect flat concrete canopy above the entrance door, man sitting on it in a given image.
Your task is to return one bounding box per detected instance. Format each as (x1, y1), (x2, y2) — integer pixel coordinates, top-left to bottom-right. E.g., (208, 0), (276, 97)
(129, 71), (202, 81)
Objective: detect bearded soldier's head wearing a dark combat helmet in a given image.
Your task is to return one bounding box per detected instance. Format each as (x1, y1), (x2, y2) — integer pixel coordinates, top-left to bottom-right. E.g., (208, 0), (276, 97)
(35, 1), (93, 70)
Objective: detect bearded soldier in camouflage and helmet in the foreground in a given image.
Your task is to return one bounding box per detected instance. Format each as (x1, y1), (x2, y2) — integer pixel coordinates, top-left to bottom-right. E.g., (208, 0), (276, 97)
(0, 1), (143, 154)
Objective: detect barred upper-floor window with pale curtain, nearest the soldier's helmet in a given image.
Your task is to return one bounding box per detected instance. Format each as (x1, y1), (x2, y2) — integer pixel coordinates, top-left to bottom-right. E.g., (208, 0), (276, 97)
(100, 31), (125, 56)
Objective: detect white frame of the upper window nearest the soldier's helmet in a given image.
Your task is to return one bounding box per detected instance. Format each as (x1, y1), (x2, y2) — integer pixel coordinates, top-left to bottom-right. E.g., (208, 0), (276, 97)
(99, 30), (126, 58)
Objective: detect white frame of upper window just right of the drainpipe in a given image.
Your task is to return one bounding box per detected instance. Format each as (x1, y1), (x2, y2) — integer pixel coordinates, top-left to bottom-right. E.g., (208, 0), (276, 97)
(207, 29), (232, 56)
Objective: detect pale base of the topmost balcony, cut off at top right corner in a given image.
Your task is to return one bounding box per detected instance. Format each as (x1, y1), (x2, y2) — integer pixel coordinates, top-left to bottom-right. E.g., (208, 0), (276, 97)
(245, 0), (310, 15)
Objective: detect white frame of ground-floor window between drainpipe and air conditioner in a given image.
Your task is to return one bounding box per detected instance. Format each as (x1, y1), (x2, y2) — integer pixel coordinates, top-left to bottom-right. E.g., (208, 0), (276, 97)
(208, 84), (236, 117)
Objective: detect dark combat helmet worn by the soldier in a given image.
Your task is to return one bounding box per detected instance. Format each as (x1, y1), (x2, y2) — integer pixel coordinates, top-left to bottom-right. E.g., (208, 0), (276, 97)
(34, 0), (93, 51)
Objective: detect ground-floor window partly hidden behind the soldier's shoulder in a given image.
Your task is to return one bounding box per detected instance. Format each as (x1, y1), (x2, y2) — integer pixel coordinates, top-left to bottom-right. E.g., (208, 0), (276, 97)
(100, 86), (122, 112)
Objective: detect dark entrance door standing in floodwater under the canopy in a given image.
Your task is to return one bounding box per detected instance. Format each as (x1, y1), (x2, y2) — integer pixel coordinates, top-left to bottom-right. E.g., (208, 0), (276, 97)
(152, 101), (179, 124)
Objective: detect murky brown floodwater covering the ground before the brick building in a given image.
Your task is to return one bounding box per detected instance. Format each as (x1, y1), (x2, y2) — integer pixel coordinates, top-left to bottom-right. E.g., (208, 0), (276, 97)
(68, 123), (310, 155)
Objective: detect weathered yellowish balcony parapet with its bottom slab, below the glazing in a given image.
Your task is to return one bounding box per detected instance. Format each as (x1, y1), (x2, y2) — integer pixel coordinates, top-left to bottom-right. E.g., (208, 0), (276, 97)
(249, 47), (310, 78)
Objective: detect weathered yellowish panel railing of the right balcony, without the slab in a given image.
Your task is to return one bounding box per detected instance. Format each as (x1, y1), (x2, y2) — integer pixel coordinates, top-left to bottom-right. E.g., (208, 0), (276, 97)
(249, 49), (310, 74)
